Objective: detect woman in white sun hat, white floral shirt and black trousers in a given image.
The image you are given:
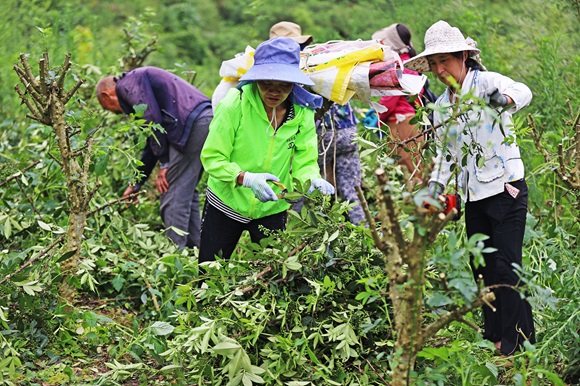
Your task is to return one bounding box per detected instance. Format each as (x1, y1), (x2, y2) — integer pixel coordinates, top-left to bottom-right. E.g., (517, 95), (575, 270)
(405, 21), (535, 355)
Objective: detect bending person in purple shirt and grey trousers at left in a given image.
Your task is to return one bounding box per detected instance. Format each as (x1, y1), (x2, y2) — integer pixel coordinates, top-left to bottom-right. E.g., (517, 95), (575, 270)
(97, 67), (213, 247)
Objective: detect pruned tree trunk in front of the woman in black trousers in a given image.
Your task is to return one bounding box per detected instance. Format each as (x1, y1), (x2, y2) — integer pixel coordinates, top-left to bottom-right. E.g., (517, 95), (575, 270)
(356, 169), (494, 386)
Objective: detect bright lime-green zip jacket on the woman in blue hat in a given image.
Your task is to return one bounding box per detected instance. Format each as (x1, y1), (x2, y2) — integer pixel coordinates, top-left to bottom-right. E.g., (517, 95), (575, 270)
(201, 83), (320, 219)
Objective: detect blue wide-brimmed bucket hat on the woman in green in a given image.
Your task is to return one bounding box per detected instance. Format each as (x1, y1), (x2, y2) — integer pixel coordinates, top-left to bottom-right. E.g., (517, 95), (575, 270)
(240, 37), (314, 86)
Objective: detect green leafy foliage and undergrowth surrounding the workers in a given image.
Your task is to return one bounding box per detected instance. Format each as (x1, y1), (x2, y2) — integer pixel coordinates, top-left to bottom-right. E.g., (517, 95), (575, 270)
(0, 0), (580, 385)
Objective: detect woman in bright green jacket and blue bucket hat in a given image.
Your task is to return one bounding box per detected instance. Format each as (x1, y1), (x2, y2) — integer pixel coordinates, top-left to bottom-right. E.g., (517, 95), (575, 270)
(199, 38), (334, 262)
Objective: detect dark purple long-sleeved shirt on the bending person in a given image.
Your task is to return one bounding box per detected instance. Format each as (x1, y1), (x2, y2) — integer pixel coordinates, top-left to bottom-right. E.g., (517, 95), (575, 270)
(115, 67), (211, 182)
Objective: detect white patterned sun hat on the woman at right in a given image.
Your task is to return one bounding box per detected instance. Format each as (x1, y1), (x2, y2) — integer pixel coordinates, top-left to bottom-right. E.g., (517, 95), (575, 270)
(404, 20), (480, 72)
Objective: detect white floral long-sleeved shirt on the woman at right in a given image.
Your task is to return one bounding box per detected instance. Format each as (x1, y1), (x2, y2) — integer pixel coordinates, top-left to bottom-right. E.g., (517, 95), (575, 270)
(429, 70), (532, 201)
